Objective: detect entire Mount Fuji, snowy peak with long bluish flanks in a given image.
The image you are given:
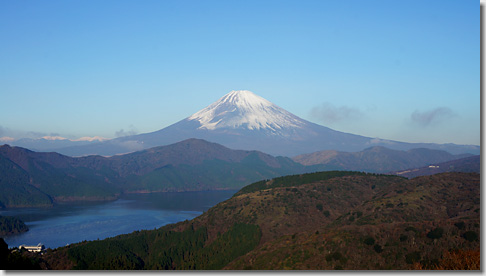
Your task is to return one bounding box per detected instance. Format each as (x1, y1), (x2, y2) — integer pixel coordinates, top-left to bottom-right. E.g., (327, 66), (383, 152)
(56, 90), (479, 156)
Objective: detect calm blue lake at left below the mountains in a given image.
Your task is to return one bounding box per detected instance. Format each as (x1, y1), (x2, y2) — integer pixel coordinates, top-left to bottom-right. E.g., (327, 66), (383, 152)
(0, 191), (236, 248)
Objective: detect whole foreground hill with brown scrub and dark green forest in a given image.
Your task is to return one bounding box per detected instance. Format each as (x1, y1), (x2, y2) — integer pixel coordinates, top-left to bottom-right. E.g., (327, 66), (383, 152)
(36, 172), (480, 270)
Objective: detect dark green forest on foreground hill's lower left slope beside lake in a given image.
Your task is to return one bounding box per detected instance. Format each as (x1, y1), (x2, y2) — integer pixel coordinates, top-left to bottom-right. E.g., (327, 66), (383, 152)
(68, 223), (261, 270)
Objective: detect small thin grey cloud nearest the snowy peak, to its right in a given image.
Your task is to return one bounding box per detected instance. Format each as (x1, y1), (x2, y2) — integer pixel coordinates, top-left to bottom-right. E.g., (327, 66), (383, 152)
(311, 103), (363, 123)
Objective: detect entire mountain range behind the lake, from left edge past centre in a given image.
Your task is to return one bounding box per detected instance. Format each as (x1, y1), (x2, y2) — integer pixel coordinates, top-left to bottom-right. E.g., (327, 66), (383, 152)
(0, 139), (306, 207)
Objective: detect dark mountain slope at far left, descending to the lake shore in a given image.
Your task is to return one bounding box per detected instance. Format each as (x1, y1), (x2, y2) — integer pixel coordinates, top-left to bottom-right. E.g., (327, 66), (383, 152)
(0, 146), (120, 207)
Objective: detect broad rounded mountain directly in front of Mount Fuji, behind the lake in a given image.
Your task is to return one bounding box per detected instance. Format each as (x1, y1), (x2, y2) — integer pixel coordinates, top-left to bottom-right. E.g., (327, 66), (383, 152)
(109, 139), (306, 191)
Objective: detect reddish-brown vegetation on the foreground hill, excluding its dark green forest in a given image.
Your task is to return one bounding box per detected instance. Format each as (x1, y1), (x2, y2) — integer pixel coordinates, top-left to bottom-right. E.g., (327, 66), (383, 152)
(37, 170), (480, 270)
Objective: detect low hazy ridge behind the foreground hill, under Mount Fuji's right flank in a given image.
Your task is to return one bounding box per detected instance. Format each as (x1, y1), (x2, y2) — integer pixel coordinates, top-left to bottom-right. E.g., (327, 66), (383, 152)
(292, 147), (470, 173)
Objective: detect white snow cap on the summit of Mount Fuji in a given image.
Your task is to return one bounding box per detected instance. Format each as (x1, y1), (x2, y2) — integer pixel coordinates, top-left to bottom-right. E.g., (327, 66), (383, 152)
(187, 90), (305, 132)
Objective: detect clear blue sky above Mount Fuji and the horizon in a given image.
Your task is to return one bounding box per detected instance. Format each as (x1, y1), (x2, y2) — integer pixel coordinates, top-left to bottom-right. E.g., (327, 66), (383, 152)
(0, 0), (480, 145)
